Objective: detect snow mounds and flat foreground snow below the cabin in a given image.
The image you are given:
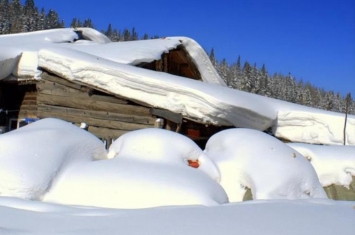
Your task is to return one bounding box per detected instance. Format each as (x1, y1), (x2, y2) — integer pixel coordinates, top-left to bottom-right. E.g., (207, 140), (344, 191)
(0, 118), (355, 235)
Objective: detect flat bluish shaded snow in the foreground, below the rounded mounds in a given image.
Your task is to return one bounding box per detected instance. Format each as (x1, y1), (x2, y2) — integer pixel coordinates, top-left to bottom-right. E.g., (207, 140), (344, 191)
(0, 197), (355, 235)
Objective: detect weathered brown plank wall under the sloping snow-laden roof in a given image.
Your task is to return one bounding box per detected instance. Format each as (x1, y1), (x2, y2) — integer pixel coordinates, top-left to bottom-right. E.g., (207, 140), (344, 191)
(37, 73), (155, 140)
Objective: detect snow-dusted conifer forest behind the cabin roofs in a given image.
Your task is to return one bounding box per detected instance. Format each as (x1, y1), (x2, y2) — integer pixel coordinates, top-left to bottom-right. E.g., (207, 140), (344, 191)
(0, 0), (355, 114)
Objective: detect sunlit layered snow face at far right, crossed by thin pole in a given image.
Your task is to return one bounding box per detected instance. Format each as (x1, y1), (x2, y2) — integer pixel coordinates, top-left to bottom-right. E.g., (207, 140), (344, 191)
(275, 111), (355, 145)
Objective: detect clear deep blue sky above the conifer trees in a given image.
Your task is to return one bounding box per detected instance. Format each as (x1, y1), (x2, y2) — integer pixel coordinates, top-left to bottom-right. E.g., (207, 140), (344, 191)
(35, 0), (355, 98)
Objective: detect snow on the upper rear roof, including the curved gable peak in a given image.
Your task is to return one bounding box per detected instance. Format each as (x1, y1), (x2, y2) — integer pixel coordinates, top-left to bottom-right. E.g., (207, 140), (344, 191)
(0, 28), (226, 86)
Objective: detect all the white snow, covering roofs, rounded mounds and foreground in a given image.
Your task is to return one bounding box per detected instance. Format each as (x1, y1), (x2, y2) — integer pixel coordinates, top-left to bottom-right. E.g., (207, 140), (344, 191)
(0, 29), (355, 235)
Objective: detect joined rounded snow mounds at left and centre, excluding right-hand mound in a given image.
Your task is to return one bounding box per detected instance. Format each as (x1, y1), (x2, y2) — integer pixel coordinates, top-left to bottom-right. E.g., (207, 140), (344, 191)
(0, 118), (228, 208)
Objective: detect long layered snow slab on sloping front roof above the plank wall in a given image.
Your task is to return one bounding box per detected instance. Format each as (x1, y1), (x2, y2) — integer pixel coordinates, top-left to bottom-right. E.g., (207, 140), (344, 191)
(39, 48), (276, 130)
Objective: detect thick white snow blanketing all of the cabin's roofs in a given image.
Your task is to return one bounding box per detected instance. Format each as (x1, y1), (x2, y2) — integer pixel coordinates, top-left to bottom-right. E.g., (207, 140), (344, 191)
(0, 29), (355, 145)
